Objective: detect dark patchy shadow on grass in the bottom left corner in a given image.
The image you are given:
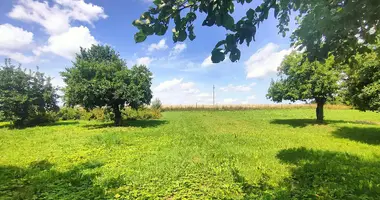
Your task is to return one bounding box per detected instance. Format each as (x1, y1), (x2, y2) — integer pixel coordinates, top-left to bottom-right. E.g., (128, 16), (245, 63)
(0, 160), (106, 199)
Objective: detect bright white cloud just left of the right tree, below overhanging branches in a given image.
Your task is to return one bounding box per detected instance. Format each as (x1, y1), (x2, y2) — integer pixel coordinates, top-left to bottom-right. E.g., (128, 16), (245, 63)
(244, 43), (292, 78)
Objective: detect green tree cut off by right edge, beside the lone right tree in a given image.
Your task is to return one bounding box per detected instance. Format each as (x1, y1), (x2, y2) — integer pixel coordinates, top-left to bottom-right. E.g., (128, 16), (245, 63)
(345, 52), (380, 112)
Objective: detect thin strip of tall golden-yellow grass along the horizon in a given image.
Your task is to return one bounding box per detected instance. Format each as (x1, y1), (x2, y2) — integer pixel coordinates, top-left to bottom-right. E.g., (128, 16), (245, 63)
(162, 104), (351, 111)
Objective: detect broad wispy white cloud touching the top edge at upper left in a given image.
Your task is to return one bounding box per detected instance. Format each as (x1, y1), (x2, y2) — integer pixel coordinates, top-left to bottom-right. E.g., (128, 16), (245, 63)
(8, 0), (107, 35)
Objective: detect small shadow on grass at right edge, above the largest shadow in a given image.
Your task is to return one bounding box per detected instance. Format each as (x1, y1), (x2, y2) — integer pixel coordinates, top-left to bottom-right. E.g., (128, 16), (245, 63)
(333, 127), (380, 145)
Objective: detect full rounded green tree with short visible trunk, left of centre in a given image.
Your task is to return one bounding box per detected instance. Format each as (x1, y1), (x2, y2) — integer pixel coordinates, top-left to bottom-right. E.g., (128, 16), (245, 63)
(61, 45), (152, 125)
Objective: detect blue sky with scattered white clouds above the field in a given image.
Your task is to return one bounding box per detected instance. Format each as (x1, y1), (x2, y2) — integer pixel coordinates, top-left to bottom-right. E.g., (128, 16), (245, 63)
(0, 0), (294, 104)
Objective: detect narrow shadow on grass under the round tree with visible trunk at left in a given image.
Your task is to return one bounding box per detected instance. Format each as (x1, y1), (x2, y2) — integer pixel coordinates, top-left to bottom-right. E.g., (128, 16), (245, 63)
(84, 120), (168, 129)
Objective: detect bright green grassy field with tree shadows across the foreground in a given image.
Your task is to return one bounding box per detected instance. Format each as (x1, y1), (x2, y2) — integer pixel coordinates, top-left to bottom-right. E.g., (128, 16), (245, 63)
(0, 109), (380, 199)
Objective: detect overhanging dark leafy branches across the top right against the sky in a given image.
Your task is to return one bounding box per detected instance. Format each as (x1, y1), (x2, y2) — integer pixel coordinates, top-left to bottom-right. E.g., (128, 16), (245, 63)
(133, 0), (380, 63)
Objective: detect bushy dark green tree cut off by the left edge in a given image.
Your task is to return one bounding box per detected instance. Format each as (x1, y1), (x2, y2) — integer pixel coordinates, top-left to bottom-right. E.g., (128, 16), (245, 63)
(0, 59), (58, 126)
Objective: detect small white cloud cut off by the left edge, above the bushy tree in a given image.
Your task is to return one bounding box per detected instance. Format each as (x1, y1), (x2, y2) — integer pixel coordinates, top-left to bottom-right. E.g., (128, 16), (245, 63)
(0, 24), (33, 50)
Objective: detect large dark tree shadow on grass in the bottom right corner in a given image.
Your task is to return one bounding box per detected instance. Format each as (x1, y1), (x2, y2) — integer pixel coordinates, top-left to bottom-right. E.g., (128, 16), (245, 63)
(277, 148), (380, 199)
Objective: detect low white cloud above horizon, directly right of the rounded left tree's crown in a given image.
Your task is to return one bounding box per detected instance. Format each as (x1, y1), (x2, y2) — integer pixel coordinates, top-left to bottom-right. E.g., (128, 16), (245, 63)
(153, 78), (212, 105)
